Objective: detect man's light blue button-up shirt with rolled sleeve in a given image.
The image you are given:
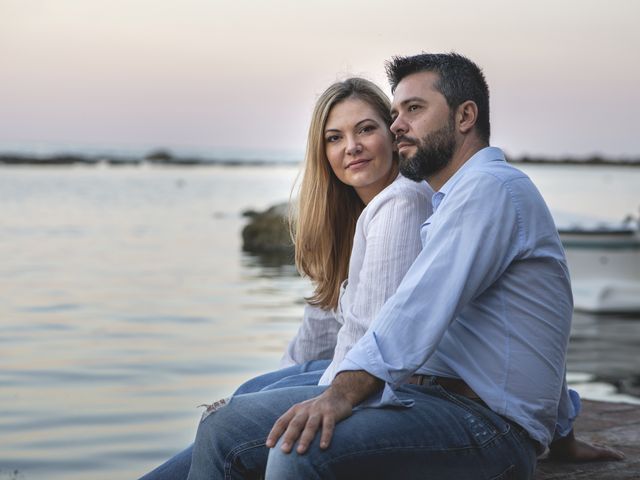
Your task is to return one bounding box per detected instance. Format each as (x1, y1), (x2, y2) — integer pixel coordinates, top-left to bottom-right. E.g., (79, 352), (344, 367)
(339, 147), (579, 445)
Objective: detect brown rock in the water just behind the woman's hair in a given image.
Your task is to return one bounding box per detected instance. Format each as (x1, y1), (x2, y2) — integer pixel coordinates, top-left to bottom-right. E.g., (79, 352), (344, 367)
(242, 203), (293, 255)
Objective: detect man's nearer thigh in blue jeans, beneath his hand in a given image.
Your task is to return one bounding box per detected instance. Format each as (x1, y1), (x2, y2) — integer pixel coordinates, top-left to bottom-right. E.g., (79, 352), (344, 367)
(267, 386), (535, 480)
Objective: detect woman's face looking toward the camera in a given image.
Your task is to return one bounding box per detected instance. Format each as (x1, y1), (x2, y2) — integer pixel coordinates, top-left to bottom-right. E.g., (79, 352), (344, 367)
(324, 98), (397, 204)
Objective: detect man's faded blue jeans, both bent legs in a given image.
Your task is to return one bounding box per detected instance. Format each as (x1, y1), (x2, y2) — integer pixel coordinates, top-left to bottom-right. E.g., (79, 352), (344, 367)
(188, 385), (536, 480)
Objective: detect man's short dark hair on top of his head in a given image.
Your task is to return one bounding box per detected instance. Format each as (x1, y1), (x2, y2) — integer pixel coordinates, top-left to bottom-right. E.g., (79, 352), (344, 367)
(386, 53), (491, 144)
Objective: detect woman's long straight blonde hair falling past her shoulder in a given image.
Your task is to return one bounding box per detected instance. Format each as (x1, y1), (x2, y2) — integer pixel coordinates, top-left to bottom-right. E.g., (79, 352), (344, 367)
(289, 78), (397, 309)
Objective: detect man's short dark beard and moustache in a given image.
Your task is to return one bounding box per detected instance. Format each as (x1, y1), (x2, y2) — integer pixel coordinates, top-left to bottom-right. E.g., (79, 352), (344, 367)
(397, 117), (456, 182)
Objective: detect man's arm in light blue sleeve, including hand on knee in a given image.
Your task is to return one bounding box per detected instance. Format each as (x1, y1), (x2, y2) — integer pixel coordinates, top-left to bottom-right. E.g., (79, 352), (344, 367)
(266, 175), (517, 453)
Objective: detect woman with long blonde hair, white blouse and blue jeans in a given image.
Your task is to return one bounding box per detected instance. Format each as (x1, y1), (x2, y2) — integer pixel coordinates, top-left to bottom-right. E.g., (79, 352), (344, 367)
(138, 78), (433, 480)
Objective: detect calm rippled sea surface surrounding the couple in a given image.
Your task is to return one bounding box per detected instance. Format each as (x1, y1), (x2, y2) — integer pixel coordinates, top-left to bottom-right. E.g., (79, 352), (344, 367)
(0, 166), (640, 480)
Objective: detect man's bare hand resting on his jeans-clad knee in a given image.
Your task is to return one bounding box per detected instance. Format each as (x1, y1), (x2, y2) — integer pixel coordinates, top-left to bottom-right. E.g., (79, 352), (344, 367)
(266, 371), (382, 454)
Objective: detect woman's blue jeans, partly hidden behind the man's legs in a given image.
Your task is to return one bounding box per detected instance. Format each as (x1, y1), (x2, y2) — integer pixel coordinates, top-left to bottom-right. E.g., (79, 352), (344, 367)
(140, 360), (330, 480)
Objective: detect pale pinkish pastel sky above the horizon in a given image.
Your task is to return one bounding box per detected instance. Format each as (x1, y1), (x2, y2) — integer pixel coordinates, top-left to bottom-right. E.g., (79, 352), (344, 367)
(0, 0), (640, 158)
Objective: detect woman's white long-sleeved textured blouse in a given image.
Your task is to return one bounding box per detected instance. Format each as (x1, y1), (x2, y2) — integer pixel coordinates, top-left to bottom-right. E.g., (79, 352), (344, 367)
(281, 175), (433, 385)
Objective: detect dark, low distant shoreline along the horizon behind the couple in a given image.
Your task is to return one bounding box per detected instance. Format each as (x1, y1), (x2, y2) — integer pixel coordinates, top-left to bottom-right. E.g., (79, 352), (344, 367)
(0, 151), (640, 167)
